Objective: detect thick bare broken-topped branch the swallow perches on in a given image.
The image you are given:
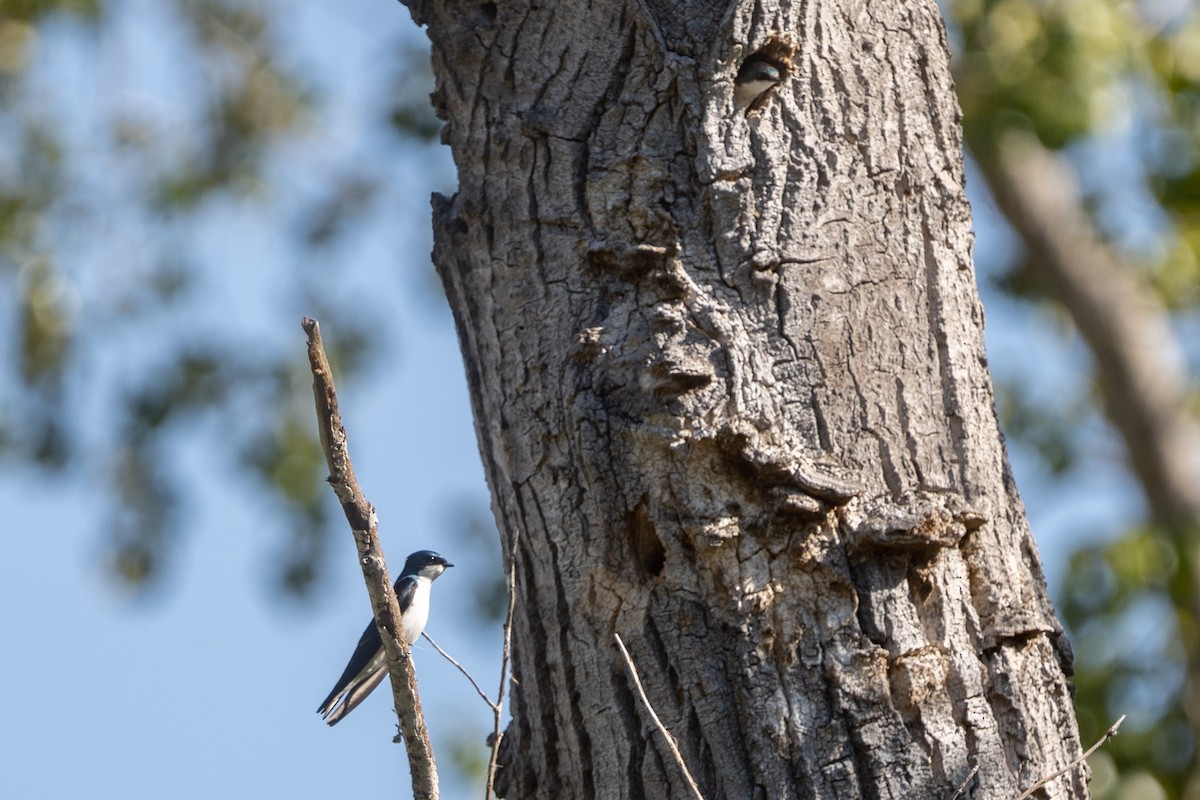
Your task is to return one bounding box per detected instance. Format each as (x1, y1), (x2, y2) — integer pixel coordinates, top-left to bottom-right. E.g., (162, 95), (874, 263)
(301, 317), (438, 800)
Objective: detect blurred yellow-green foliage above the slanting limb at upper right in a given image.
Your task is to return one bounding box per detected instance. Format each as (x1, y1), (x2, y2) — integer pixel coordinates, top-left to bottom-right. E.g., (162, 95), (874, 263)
(948, 0), (1200, 298)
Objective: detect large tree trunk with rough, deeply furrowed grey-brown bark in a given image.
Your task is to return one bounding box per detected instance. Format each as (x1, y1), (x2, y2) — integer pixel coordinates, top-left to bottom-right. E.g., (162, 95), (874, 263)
(409, 0), (1087, 800)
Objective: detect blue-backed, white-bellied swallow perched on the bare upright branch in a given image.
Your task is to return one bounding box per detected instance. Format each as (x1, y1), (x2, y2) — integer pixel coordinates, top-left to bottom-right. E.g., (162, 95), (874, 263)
(317, 551), (454, 724)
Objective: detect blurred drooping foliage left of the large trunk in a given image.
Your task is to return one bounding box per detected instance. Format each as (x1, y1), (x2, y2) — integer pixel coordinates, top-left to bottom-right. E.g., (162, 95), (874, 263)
(0, 0), (439, 596)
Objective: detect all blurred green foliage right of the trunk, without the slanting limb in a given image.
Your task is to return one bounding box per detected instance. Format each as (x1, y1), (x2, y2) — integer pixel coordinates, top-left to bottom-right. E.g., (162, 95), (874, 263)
(946, 0), (1200, 799)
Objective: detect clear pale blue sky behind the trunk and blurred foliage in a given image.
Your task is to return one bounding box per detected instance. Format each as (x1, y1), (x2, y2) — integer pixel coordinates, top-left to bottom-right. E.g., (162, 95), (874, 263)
(0, 0), (1139, 799)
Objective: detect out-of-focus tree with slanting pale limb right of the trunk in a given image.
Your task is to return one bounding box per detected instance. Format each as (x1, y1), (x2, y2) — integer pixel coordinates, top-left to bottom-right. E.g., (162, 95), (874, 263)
(949, 0), (1200, 798)
